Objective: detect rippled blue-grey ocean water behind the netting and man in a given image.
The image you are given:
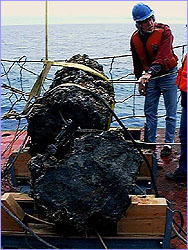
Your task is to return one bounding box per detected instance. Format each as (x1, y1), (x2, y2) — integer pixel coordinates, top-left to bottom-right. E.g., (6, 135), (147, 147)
(1, 23), (187, 130)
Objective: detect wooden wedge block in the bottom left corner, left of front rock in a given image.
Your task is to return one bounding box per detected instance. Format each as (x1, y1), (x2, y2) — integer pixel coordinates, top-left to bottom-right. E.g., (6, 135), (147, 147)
(1, 193), (25, 231)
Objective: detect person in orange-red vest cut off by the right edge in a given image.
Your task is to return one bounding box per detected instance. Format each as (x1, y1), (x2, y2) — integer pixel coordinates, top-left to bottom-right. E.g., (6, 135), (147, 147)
(166, 53), (187, 181)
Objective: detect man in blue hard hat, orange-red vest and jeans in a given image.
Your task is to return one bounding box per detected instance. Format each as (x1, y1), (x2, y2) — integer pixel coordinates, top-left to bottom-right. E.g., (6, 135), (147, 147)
(130, 3), (178, 156)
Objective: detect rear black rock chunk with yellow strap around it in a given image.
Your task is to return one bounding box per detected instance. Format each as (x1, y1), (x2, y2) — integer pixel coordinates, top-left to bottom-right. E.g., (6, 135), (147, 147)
(27, 55), (114, 154)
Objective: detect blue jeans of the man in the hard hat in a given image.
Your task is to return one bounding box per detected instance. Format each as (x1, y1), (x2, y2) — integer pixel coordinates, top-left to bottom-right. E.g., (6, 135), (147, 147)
(144, 67), (177, 142)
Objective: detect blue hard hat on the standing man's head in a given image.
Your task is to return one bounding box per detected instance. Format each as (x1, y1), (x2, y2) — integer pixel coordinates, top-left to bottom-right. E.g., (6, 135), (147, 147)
(132, 3), (154, 22)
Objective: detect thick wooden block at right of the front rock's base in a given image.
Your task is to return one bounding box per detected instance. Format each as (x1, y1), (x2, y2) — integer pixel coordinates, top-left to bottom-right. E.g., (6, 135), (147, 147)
(117, 195), (167, 236)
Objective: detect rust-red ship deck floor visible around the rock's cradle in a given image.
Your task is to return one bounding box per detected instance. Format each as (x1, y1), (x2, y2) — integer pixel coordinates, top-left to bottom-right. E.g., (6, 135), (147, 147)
(1, 129), (187, 249)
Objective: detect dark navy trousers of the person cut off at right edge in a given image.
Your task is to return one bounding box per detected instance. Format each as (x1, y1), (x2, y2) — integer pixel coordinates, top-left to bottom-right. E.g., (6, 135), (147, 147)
(176, 108), (187, 174)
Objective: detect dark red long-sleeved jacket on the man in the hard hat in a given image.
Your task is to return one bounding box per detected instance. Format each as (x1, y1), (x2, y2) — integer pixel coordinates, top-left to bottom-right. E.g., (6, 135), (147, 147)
(131, 23), (178, 77)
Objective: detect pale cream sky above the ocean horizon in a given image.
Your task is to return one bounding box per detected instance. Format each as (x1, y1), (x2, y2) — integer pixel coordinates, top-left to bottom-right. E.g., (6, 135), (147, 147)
(1, 0), (187, 25)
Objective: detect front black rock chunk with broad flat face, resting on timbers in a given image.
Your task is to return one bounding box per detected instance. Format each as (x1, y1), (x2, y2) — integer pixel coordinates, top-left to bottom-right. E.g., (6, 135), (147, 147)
(29, 131), (141, 232)
